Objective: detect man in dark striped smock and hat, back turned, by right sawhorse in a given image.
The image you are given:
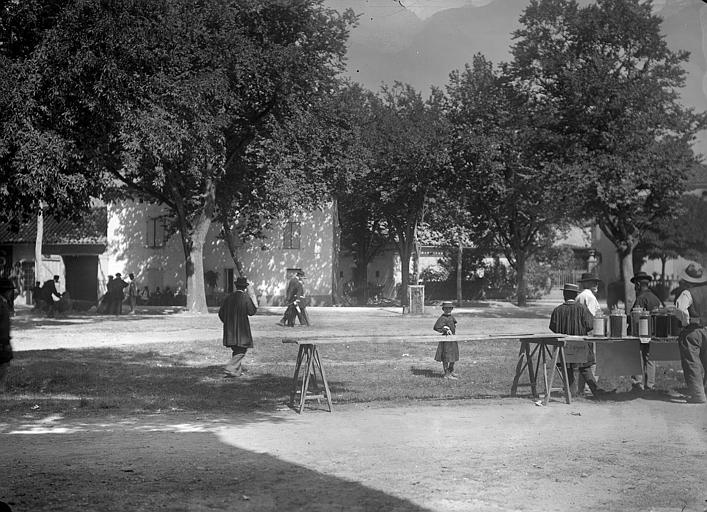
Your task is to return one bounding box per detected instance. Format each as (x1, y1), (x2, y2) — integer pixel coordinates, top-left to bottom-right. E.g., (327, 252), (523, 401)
(550, 283), (606, 397)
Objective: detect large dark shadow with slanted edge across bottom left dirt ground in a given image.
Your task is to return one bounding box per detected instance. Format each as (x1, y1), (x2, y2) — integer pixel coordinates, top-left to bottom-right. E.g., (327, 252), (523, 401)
(0, 431), (432, 512)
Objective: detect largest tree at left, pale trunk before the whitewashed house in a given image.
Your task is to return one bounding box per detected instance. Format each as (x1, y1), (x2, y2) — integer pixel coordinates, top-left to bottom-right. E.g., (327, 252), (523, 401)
(2, 0), (355, 311)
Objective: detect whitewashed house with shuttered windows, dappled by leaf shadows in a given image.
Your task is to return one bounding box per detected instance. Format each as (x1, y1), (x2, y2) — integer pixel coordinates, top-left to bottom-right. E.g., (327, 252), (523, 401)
(104, 201), (335, 305)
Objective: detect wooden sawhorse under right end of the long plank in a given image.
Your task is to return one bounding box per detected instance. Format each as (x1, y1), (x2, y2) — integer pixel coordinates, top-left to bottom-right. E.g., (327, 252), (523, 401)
(511, 335), (572, 405)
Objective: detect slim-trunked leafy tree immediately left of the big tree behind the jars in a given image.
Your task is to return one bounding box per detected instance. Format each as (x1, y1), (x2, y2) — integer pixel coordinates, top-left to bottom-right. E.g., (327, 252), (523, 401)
(447, 55), (576, 306)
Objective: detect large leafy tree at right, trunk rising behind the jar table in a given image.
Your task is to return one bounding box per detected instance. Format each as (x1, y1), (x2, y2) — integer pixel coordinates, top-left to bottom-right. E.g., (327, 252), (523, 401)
(512, 0), (705, 303)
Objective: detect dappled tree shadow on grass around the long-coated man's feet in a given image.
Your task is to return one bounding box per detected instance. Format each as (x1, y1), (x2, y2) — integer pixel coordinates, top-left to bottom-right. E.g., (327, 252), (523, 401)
(0, 349), (347, 417)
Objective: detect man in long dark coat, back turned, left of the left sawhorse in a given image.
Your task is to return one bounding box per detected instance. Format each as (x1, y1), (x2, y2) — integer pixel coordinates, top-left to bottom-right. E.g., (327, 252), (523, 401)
(218, 277), (258, 377)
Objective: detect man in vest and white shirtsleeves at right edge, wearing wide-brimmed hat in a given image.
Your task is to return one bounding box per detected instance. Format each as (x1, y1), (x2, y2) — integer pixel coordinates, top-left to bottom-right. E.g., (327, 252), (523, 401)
(675, 263), (707, 404)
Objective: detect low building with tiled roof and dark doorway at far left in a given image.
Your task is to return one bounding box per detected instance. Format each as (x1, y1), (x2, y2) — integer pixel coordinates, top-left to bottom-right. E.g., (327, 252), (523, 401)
(0, 207), (107, 302)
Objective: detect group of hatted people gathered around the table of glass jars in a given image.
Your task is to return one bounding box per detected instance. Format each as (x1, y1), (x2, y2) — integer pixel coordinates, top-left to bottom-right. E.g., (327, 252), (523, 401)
(550, 263), (707, 403)
